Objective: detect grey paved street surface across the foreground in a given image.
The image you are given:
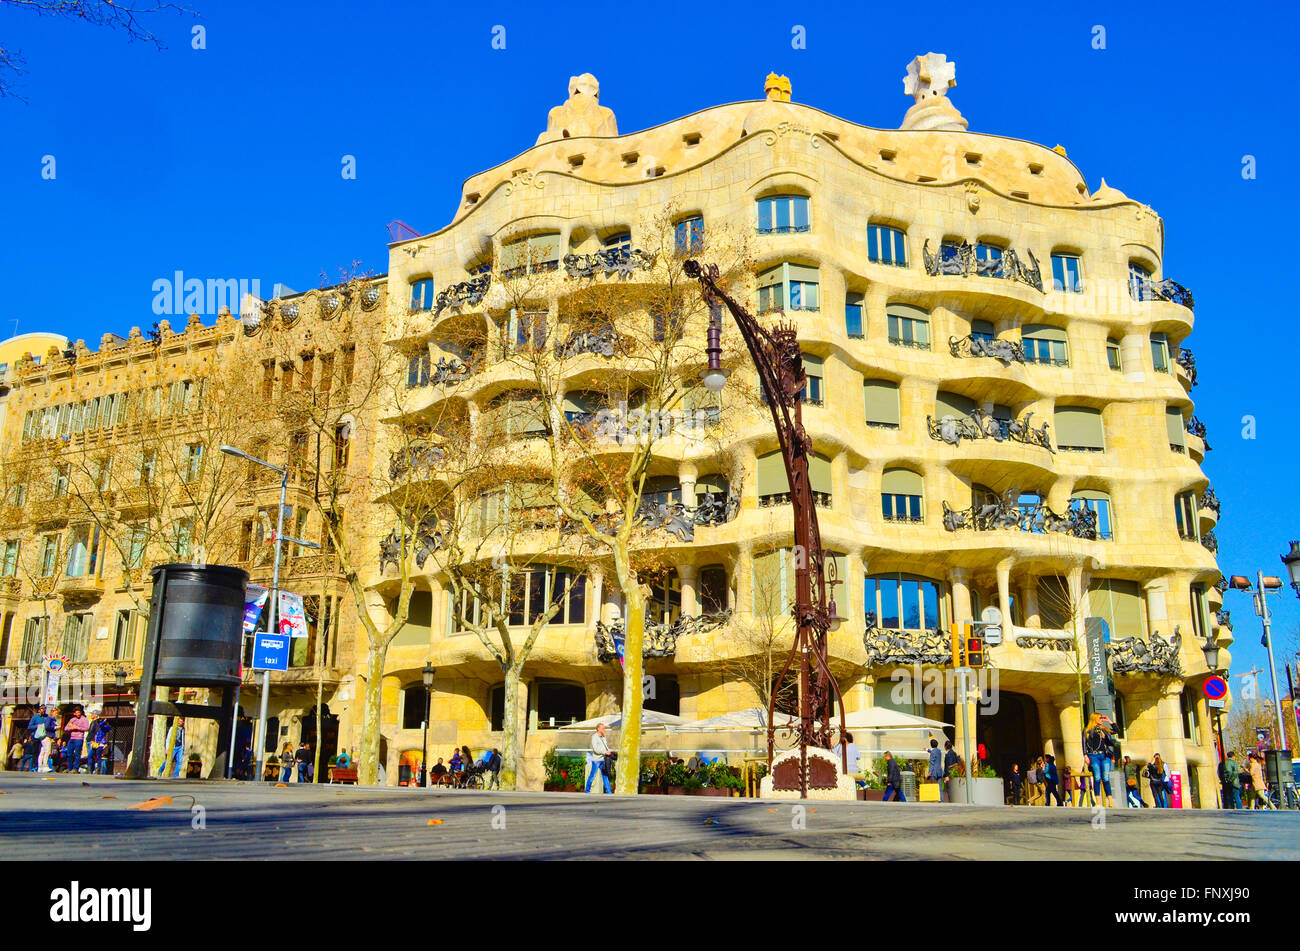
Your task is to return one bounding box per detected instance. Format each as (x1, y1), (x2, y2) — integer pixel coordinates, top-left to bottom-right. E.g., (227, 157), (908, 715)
(0, 773), (1300, 861)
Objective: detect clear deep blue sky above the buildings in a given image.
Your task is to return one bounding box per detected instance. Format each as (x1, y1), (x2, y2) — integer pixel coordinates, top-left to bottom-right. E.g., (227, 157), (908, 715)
(0, 0), (1300, 706)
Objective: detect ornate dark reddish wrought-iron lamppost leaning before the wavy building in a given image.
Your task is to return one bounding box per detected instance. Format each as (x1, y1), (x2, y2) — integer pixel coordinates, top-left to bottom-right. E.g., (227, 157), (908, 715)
(685, 260), (849, 799)
